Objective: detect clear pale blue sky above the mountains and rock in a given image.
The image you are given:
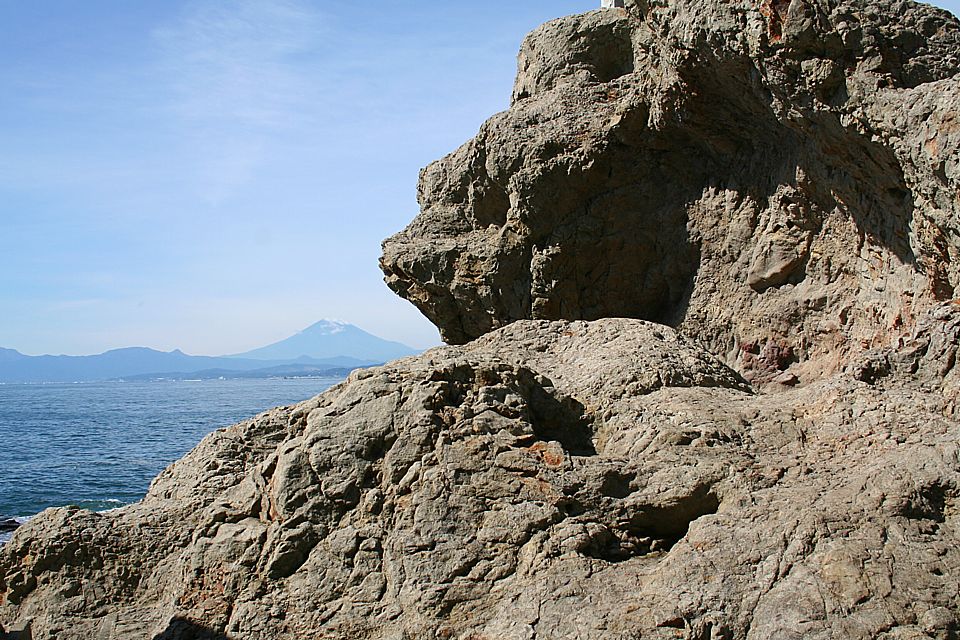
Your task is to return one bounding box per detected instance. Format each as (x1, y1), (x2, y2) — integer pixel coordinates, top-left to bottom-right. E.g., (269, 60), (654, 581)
(0, 0), (960, 354)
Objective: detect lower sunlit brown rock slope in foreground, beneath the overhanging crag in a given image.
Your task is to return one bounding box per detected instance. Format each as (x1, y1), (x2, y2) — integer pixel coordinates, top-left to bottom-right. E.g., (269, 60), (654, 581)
(0, 304), (960, 640)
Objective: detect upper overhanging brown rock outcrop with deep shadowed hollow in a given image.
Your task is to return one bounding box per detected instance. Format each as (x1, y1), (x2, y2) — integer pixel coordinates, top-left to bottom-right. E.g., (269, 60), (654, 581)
(381, 0), (960, 382)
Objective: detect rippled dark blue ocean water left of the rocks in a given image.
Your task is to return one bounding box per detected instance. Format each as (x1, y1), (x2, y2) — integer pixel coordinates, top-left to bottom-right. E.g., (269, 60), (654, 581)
(0, 378), (340, 541)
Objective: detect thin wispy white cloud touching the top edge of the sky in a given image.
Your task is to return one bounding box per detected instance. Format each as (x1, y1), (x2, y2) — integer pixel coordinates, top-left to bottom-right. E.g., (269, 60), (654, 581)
(153, 0), (324, 204)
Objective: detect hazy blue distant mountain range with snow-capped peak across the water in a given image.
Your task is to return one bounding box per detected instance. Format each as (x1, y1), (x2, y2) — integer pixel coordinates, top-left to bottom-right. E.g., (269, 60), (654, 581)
(0, 320), (417, 383)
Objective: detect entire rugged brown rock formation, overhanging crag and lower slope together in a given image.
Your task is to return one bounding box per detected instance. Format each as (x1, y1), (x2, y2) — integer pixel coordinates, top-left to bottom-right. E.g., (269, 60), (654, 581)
(0, 0), (960, 640)
